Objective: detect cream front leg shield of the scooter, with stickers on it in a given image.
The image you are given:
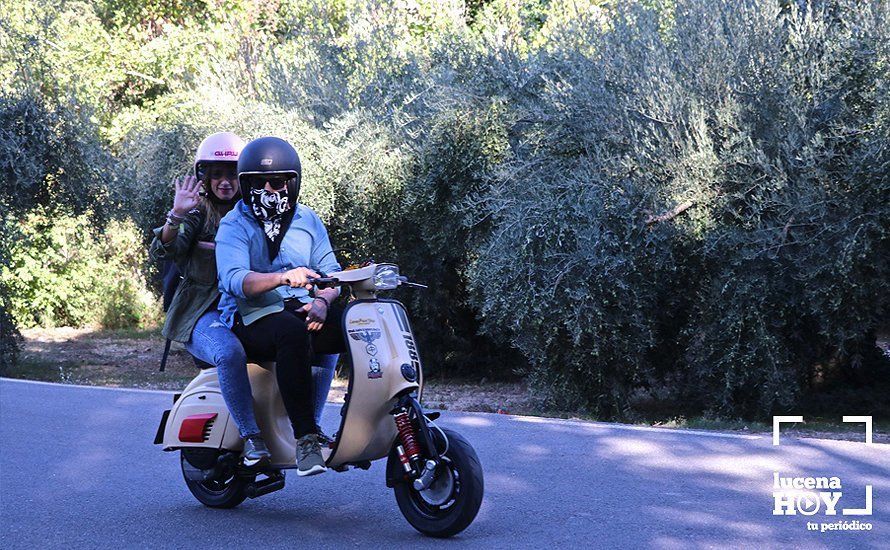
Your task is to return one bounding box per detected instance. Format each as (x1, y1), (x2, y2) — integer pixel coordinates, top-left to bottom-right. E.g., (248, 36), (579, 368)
(328, 300), (421, 467)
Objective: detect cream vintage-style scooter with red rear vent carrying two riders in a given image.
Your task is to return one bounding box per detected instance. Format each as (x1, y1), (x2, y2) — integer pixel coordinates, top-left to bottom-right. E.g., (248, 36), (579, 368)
(155, 263), (484, 537)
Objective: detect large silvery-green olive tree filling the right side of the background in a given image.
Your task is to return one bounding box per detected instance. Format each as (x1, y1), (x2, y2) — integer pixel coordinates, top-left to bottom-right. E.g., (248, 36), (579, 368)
(462, 0), (888, 416)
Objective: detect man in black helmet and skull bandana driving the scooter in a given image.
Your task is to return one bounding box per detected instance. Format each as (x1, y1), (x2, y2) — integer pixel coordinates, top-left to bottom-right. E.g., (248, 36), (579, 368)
(216, 137), (345, 476)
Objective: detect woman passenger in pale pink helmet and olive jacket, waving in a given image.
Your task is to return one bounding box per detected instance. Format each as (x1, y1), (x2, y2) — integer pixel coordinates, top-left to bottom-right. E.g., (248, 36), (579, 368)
(149, 132), (337, 467)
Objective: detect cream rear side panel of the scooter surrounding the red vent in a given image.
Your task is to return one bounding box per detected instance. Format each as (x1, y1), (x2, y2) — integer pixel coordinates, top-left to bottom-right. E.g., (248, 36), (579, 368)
(164, 369), (231, 450)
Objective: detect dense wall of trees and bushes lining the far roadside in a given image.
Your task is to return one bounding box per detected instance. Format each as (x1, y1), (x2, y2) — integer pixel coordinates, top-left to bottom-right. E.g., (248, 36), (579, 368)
(0, 0), (890, 416)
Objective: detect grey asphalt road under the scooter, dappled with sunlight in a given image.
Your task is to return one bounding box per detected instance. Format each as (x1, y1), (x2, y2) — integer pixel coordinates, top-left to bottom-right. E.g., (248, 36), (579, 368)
(0, 379), (890, 549)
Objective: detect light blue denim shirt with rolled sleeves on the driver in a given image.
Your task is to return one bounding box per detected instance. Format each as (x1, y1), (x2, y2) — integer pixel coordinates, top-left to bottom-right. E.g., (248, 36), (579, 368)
(216, 201), (340, 328)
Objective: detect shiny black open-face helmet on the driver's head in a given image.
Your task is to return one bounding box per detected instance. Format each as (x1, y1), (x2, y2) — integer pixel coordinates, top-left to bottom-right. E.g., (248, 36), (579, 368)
(238, 136), (303, 204)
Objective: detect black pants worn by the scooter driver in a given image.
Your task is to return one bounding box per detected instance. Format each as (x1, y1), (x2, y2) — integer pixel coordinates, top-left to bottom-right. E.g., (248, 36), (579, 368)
(232, 301), (346, 438)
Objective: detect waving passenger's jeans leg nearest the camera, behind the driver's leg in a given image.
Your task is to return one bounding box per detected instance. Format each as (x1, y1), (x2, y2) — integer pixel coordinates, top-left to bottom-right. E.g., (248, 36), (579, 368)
(185, 309), (260, 437)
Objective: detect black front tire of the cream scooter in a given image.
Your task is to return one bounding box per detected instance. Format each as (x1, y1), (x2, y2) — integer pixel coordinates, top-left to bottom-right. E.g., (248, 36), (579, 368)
(393, 429), (485, 538)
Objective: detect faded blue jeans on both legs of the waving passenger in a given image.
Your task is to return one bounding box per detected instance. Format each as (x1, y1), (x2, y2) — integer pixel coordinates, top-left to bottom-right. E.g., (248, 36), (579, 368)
(185, 310), (340, 437)
